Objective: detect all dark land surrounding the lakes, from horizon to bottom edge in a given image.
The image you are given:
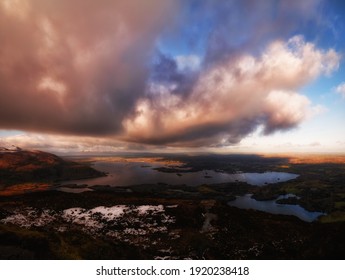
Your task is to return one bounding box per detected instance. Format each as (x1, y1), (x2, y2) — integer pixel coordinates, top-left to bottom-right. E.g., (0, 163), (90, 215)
(0, 151), (345, 259)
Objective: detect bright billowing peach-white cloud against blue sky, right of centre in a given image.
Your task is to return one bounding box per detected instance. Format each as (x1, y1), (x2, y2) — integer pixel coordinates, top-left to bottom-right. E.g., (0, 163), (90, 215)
(123, 36), (340, 146)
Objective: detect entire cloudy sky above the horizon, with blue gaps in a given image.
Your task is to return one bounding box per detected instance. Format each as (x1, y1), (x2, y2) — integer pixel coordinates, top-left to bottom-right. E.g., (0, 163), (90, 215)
(0, 0), (345, 154)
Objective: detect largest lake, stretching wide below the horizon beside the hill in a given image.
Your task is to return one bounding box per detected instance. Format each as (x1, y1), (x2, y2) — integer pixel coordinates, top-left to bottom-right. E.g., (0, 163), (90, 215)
(63, 160), (299, 186)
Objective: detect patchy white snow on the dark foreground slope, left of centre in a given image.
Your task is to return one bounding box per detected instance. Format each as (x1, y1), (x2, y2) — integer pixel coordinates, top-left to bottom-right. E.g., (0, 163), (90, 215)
(0, 205), (176, 244)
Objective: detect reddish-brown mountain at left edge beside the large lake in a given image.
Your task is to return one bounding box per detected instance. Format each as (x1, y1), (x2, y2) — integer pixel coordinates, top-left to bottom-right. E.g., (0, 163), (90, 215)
(0, 147), (104, 189)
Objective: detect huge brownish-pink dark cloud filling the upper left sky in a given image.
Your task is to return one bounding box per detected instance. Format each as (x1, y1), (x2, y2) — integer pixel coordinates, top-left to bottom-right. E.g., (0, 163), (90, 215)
(0, 0), (176, 136)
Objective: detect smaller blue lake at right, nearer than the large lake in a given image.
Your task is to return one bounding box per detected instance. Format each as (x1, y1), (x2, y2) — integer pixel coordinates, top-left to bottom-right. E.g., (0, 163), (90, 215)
(228, 194), (324, 222)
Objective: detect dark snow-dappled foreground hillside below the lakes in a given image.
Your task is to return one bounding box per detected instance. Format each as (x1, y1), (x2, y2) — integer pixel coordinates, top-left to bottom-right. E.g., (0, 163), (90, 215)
(0, 187), (345, 259)
